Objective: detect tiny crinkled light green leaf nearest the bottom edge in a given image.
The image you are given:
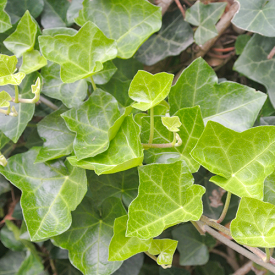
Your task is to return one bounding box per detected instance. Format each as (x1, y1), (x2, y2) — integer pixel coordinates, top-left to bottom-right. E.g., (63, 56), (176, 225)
(148, 239), (178, 265)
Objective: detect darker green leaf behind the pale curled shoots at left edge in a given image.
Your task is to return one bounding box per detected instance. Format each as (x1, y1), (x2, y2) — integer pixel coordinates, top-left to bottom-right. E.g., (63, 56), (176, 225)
(0, 73), (36, 142)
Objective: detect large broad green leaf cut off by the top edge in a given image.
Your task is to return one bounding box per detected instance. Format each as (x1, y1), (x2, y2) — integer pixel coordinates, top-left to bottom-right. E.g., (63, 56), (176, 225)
(75, 0), (161, 59)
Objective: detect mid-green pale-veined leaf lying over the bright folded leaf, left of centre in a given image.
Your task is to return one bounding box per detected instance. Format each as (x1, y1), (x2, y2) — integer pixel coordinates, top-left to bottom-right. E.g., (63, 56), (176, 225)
(62, 89), (131, 160)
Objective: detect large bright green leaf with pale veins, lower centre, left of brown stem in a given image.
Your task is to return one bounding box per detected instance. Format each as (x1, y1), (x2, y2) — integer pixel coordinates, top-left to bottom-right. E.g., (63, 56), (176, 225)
(126, 161), (205, 239)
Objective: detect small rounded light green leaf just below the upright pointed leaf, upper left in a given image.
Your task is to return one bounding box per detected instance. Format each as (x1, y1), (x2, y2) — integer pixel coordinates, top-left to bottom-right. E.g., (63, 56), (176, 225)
(20, 50), (47, 74)
